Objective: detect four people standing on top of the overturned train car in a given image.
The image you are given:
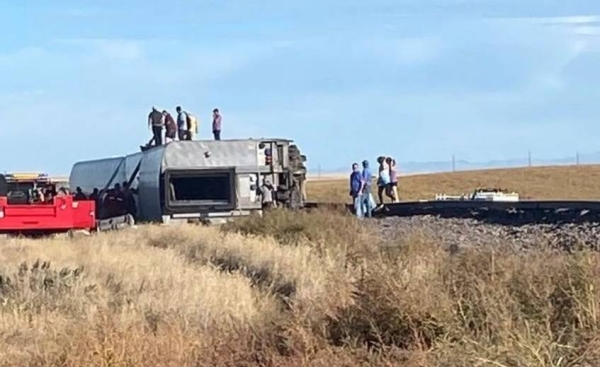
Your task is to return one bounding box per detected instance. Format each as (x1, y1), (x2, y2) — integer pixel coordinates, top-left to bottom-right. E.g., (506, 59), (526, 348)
(146, 106), (222, 147)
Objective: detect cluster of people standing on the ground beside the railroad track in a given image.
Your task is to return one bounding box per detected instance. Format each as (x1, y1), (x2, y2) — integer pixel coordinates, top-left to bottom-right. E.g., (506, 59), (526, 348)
(350, 156), (399, 218)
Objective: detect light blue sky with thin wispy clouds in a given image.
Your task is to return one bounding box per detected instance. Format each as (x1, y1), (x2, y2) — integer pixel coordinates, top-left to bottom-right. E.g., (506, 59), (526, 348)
(0, 0), (600, 174)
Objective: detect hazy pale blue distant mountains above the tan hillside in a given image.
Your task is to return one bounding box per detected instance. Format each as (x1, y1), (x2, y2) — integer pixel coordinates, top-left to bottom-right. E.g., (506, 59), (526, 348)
(309, 152), (600, 176)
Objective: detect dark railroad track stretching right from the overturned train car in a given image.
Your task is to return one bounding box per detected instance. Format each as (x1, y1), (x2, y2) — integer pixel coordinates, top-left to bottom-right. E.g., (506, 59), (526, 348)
(305, 200), (600, 226)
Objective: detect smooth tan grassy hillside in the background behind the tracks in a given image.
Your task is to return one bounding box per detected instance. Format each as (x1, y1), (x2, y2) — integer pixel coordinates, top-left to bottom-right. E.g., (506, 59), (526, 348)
(307, 165), (600, 202)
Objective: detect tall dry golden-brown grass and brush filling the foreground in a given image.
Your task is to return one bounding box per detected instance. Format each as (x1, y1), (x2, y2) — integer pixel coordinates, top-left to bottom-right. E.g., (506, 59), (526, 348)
(0, 211), (600, 366)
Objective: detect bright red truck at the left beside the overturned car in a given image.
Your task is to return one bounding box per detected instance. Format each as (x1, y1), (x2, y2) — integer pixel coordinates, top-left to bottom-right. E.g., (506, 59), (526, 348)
(0, 174), (97, 235)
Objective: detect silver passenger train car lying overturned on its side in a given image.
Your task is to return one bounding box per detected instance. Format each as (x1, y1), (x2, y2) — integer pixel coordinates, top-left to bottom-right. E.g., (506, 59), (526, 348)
(69, 139), (306, 223)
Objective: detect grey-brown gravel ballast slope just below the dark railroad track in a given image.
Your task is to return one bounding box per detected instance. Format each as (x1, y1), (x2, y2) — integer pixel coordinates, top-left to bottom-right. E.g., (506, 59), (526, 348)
(375, 216), (600, 251)
